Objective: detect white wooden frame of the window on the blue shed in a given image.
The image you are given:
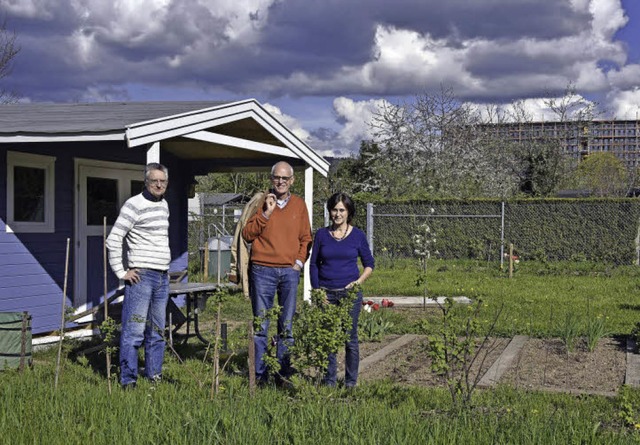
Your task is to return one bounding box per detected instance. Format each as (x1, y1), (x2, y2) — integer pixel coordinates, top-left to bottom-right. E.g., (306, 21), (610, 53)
(6, 151), (56, 233)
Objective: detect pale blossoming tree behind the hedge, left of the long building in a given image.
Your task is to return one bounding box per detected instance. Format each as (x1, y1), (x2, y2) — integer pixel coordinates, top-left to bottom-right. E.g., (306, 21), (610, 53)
(370, 87), (514, 197)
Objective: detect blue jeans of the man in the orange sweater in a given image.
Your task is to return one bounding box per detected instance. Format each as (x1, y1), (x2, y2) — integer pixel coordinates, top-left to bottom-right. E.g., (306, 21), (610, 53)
(249, 264), (300, 382)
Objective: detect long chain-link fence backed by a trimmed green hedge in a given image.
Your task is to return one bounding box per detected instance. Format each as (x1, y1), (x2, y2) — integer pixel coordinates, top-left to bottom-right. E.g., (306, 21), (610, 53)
(189, 199), (640, 276)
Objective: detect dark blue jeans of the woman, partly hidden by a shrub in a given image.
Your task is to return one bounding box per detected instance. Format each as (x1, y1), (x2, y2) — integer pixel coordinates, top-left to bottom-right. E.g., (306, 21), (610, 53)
(323, 290), (362, 387)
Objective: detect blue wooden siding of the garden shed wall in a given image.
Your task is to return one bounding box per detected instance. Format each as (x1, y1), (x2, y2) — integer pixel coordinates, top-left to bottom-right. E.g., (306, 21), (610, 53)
(0, 142), (192, 334)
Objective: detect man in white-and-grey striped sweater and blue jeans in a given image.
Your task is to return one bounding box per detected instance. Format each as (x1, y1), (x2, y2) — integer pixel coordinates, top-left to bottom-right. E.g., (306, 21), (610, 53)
(107, 163), (171, 388)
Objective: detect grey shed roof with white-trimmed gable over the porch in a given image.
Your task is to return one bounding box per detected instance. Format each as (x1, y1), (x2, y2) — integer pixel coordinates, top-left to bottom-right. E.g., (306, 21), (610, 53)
(0, 99), (329, 176)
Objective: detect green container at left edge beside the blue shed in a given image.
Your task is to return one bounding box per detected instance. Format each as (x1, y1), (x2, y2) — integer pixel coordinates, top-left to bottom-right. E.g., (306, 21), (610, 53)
(0, 312), (31, 371)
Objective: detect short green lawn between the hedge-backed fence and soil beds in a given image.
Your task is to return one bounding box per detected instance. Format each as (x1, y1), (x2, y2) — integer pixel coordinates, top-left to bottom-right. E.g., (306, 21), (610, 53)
(365, 260), (640, 337)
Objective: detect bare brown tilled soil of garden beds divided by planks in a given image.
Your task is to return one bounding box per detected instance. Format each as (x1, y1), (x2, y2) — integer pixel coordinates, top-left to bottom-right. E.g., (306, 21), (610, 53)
(348, 336), (626, 393)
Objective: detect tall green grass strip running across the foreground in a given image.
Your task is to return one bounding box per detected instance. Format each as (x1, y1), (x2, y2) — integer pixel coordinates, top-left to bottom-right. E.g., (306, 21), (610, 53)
(0, 352), (640, 445)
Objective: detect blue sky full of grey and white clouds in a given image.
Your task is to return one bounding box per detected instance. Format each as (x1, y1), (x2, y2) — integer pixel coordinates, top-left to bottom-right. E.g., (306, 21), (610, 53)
(0, 0), (640, 155)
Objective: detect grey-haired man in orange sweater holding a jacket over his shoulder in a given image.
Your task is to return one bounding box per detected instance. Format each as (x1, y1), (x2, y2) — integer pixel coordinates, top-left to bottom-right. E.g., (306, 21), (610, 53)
(242, 162), (312, 384)
